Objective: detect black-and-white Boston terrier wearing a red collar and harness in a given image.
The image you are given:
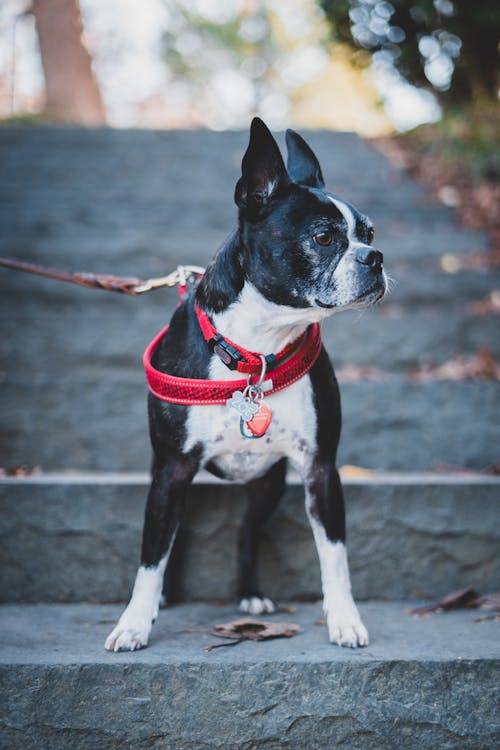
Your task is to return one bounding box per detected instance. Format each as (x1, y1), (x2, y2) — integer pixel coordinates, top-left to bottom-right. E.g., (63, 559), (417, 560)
(105, 118), (387, 651)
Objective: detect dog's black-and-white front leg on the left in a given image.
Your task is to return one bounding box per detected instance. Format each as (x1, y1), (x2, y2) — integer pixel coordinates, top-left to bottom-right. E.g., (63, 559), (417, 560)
(105, 461), (197, 651)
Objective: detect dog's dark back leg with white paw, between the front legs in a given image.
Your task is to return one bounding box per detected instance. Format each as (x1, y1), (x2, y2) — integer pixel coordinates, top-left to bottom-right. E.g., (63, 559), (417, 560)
(238, 458), (287, 615)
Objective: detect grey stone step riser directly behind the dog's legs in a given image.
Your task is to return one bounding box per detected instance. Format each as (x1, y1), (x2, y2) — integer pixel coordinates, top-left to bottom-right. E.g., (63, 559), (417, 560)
(0, 472), (500, 602)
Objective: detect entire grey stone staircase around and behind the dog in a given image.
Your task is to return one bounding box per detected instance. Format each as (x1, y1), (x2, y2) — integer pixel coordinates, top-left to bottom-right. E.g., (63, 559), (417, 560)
(0, 128), (500, 750)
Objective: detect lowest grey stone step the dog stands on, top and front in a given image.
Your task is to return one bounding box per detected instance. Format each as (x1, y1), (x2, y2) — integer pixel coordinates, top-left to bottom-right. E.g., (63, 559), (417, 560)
(0, 602), (500, 750)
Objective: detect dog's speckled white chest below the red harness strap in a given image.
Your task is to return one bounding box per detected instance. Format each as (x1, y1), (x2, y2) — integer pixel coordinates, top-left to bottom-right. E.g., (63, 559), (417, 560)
(184, 376), (316, 482)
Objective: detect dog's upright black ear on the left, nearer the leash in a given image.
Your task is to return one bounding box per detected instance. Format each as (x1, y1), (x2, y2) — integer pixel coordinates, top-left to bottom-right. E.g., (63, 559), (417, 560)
(234, 117), (290, 214)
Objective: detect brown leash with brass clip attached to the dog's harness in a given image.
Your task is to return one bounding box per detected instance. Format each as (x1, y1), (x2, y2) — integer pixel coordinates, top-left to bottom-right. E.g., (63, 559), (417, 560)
(0, 258), (205, 296)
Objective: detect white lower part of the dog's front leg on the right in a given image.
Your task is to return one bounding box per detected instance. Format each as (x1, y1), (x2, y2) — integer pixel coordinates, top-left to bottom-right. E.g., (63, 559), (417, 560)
(307, 498), (368, 647)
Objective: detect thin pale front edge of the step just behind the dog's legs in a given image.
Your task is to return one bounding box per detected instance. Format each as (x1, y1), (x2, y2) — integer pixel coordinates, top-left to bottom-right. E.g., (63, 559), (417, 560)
(0, 467), (500, 487)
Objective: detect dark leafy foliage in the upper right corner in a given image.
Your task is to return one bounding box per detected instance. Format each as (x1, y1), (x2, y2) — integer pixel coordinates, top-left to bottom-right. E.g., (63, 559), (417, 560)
(319, 0), (500, 108)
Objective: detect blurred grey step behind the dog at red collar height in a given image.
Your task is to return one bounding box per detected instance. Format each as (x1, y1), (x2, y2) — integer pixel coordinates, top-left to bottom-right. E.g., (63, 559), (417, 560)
(0, 286), (500, 372)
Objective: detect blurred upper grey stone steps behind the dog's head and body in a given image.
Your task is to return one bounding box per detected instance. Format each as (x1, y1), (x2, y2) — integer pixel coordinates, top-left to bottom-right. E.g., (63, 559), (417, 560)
(0, 128), (500, 470)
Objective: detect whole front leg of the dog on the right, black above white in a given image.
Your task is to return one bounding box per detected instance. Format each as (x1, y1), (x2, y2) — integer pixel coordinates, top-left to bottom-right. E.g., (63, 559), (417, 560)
(305, 462), (368, 648)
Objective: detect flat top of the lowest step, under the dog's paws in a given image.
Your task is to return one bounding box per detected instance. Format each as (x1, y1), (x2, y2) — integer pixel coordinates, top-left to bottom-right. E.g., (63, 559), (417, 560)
(0, 601), (500, 669)
